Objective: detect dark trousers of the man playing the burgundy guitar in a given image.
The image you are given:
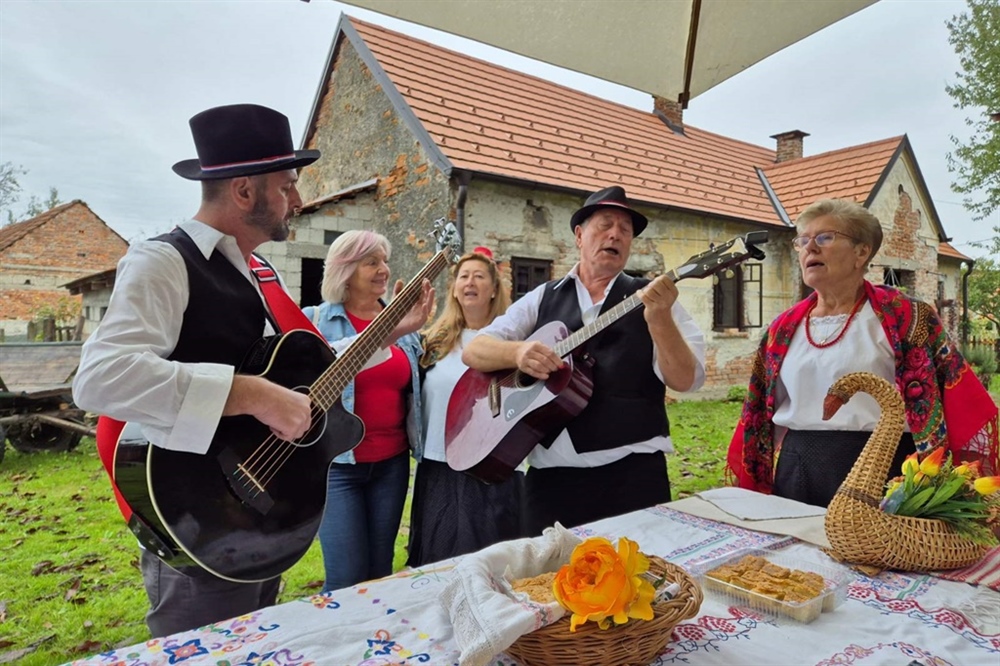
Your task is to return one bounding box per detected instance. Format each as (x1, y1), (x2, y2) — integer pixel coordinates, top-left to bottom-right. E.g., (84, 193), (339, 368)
(522, 446), (670, 536)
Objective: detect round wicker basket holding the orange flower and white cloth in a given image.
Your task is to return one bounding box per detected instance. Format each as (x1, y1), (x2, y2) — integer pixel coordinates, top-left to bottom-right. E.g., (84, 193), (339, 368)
(507, 556), (702, 666)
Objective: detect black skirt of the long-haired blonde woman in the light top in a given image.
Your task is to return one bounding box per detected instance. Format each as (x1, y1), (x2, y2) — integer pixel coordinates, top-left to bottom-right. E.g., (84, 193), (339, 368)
(406, 460), (524, 567)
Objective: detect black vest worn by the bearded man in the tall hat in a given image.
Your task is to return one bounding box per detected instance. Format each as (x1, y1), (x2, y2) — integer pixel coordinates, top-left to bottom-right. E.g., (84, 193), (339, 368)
(153, 229), (267, 368)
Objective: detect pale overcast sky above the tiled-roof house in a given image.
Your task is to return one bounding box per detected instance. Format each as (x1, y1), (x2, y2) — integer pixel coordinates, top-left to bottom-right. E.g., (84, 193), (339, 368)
(0, 0), (1000, 257)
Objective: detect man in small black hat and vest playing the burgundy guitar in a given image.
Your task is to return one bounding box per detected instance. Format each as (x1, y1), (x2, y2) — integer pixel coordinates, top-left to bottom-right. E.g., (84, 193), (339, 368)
(462, 186), (705, 534)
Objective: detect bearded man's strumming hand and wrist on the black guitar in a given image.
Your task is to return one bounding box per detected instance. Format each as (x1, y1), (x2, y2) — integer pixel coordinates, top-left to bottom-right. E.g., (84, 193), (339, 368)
(222, 375), (312, 442)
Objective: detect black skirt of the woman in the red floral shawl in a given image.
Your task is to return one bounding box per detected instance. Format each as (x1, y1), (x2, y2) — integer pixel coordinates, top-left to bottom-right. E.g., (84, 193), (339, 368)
(773, 430), (917, 506)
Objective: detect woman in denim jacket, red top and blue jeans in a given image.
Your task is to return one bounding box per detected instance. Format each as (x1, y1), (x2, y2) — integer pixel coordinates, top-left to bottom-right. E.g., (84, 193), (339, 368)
(303, 231), (433, 591)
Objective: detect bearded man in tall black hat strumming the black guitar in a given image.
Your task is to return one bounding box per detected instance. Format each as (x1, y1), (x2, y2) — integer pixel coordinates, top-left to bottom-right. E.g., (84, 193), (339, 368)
(73, 104), (431, 637)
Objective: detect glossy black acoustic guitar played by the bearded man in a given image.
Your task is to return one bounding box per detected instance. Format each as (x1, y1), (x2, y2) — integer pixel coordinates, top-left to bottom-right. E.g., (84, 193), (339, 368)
(114, 221), (459, 582)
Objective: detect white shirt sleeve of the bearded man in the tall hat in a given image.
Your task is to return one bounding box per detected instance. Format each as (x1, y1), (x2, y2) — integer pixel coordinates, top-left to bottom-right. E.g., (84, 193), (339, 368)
(73, 241), (235, 453)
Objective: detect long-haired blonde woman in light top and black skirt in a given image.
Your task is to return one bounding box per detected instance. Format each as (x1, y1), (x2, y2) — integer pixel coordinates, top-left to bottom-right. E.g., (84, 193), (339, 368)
(407, 247), (523, 566)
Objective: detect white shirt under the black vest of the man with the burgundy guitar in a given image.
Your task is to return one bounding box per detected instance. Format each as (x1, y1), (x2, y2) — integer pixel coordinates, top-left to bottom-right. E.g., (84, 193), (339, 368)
(480, 264), (705, 468)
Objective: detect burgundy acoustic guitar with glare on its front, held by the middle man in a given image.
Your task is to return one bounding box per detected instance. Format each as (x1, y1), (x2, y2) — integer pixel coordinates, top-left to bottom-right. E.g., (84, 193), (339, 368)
(445, 231), (767, 483)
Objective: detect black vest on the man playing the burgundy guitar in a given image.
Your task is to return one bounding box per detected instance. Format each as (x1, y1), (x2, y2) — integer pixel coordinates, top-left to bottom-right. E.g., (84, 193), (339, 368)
(535, 273), (670, 453)
